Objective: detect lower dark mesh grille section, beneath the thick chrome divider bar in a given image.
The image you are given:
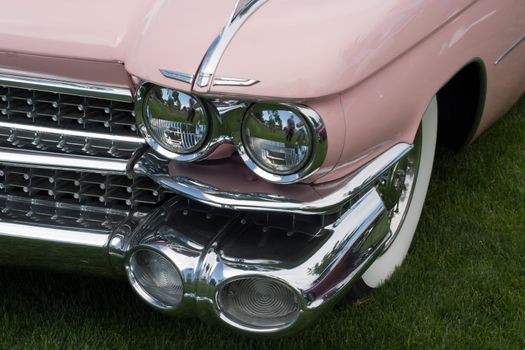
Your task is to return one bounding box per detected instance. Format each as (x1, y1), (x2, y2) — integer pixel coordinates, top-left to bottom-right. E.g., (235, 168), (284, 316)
(0, 165), (170, 210)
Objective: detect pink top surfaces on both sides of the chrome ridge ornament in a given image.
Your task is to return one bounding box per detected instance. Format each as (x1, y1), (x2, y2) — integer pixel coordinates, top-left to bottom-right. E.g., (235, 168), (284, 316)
(0, 0), (476, 99)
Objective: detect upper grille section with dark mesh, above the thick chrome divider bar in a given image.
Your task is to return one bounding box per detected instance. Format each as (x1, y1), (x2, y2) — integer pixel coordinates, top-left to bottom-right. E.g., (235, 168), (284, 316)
(0, 85), (144, 159)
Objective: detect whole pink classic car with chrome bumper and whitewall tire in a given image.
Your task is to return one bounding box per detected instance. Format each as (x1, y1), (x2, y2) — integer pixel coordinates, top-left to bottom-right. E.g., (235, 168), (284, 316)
(0, 0), (525, 335)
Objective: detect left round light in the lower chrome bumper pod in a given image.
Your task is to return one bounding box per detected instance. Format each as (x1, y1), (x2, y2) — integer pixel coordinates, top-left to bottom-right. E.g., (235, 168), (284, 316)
(128, 249), (184, 308)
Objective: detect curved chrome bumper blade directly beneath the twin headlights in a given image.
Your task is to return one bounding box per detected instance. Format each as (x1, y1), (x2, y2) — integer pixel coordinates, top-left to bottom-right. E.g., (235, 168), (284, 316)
(134, 143), (412, 215)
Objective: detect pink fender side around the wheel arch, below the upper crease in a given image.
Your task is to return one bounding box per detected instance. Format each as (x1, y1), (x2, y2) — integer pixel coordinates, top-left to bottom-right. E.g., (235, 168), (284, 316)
(322, 1), (525, 181)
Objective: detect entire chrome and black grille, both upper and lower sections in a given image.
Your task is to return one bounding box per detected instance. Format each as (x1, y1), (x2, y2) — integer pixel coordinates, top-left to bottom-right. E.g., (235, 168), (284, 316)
(0, 74), (176, 216)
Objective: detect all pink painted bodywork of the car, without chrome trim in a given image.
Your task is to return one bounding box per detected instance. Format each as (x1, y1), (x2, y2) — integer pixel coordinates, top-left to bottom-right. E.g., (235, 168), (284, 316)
(0, 0), (525, 183)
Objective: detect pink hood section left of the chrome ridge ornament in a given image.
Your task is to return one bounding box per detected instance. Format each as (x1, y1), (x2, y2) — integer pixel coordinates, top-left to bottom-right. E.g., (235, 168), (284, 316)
(0, 0), (235, 88)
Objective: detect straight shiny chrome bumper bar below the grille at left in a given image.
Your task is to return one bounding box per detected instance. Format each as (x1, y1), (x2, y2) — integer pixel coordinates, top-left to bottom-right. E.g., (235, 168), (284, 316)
(0, 222), (110, 249)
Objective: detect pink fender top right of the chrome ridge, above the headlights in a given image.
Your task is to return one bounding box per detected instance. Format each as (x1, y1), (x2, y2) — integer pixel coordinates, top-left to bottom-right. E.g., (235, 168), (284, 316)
(211, 0), (476, 100)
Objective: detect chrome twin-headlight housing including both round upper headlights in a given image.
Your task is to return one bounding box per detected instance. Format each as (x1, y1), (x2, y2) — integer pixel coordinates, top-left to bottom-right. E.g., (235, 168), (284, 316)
(135, 83), (328, 184)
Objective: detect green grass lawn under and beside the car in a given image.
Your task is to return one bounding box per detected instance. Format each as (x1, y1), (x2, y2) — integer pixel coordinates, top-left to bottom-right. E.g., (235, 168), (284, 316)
(0, 98), (525, 349)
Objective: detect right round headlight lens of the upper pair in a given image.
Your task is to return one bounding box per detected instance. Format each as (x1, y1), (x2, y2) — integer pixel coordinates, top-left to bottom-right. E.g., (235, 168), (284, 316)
(242, 103), (312, 175)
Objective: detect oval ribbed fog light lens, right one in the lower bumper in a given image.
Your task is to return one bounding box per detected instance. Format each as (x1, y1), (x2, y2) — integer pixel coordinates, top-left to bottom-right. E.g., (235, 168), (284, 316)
(218, 278), (299, 329)
